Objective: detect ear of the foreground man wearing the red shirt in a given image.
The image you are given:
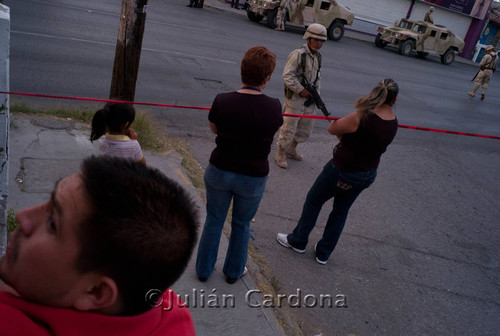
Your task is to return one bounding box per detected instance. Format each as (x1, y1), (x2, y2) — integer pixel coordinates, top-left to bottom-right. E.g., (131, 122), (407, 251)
(73, 276), (121, 314)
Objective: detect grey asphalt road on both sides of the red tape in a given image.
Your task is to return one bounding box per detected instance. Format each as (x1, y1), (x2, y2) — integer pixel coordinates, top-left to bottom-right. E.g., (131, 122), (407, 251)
(5, 0), (500, 336)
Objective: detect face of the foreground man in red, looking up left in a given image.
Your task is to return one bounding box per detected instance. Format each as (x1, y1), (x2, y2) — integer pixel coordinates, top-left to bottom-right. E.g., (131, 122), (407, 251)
(0, 174), (90, 307)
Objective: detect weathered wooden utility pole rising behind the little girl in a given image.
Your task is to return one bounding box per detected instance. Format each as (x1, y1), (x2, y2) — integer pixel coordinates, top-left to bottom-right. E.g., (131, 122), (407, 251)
(109, 0), (148, 101)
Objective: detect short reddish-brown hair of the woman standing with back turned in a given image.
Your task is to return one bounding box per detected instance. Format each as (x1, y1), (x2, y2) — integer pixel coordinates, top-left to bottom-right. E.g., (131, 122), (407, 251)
(241, 46), (276, 86)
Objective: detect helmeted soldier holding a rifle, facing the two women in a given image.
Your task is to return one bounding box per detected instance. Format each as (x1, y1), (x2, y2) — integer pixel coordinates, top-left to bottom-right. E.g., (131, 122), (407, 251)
(275, 23), (327, 168)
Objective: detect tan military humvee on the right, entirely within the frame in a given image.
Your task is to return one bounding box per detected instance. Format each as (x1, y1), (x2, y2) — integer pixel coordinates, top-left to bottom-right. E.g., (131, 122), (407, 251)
(375, 19), (464, 64)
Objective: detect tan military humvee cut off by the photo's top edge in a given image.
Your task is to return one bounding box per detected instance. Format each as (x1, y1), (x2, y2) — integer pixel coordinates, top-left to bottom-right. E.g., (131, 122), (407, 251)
(245, 0), (354, 41)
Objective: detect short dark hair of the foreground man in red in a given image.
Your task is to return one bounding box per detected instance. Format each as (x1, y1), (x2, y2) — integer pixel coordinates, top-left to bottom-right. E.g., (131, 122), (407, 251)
(76, 156), (198, 315)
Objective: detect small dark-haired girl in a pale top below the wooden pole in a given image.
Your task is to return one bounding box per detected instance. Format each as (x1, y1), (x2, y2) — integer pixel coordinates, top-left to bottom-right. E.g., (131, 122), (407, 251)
(90, 103), (146, 164)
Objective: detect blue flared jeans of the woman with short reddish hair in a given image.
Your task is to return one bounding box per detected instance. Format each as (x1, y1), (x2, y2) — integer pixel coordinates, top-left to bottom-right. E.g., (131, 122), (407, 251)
(196, 164), (267, 278)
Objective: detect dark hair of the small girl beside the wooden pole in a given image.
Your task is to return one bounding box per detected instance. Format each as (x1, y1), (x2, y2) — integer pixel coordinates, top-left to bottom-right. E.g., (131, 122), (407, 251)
(90, 103), (135, 141)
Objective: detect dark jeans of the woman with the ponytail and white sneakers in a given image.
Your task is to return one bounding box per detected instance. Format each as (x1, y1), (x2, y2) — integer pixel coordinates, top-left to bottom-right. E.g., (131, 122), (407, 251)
(287, 161), (377, 260)
